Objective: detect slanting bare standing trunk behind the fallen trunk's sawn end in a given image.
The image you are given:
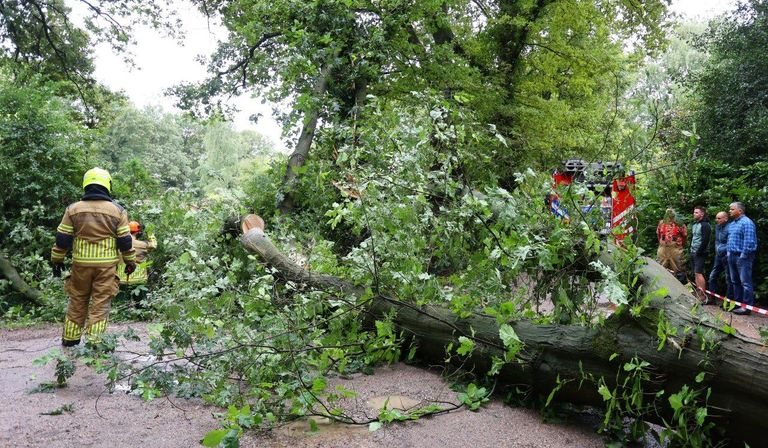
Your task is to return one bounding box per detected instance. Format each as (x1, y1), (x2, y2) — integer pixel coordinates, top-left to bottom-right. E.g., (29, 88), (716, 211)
(277, 63), (331, 215)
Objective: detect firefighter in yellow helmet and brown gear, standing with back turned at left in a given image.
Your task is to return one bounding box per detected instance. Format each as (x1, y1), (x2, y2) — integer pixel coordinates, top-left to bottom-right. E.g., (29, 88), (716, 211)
(51, 168), (136, 347)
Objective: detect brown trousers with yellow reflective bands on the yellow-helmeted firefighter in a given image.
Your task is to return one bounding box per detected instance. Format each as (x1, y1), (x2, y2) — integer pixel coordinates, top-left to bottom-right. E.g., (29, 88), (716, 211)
(62, 265), (120, 346)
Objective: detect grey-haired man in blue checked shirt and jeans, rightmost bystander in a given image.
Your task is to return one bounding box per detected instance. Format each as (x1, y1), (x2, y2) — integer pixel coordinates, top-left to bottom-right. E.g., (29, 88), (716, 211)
(728, 202), (757, 315)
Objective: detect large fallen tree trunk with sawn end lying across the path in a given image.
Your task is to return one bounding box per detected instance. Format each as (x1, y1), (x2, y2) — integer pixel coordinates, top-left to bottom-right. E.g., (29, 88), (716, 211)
(241, 220), (768, 446)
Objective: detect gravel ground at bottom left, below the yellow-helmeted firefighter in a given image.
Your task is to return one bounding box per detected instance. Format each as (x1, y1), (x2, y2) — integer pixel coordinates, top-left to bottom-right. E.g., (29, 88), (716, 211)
(0, 325), (218, 447)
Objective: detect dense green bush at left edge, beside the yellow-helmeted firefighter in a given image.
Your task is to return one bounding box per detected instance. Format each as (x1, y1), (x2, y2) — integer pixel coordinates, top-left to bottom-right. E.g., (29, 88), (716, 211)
(0, 79), (89, 313)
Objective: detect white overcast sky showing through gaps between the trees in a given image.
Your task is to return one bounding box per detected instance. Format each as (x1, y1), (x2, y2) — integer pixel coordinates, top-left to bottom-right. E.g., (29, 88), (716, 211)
(79, 0), (736, 154)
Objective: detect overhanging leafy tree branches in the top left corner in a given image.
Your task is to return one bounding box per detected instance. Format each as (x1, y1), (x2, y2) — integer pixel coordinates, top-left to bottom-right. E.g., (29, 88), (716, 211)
(0, 0), (177, 127)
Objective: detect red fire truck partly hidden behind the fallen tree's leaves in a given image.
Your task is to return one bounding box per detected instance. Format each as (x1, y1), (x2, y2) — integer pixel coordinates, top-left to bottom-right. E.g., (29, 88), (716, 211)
(546, 159), (637, 243)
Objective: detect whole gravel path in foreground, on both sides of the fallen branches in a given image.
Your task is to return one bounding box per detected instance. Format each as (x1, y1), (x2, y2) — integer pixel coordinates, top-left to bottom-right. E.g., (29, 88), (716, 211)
(0, 324), (605, 448)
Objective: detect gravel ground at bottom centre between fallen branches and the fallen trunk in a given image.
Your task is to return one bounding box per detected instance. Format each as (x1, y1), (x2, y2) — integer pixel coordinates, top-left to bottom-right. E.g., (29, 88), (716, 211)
(243, 363), (605, 448)
